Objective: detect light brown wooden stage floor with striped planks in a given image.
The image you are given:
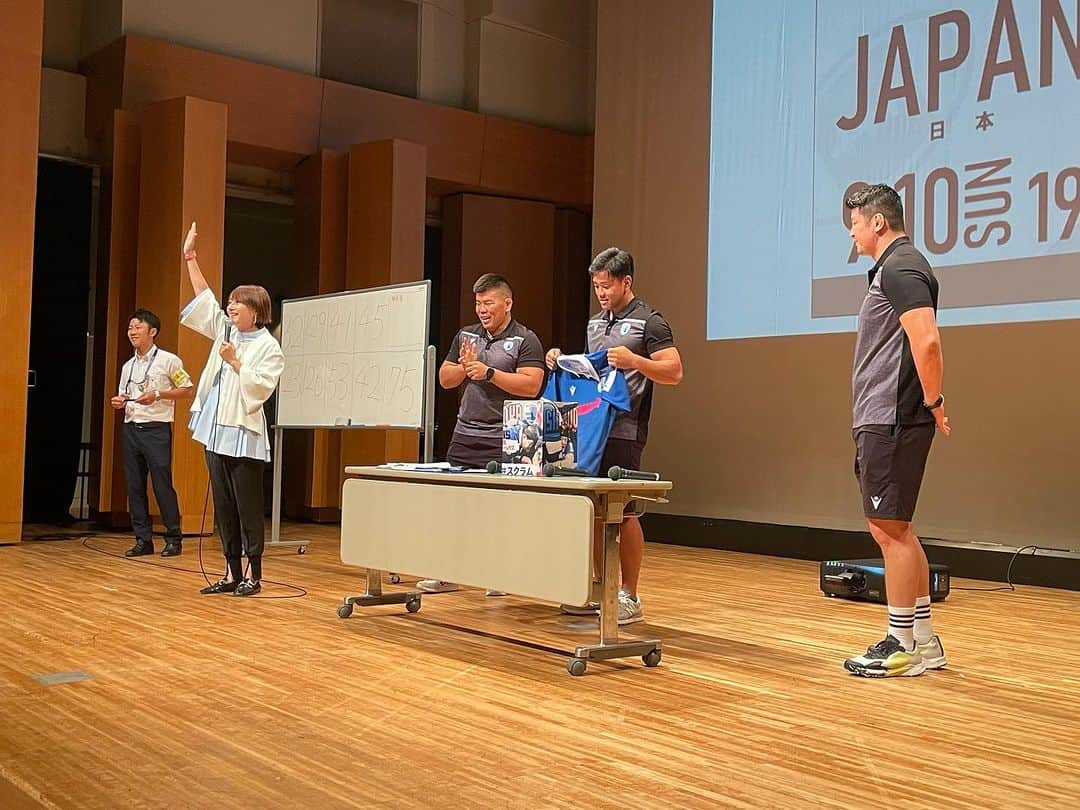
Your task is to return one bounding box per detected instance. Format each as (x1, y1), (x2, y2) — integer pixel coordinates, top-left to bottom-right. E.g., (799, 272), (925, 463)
(0, 526), (1080, 808)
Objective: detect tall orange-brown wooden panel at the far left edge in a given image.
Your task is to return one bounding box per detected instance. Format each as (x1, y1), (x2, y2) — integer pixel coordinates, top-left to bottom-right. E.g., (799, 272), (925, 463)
(0, 0), (44, 543)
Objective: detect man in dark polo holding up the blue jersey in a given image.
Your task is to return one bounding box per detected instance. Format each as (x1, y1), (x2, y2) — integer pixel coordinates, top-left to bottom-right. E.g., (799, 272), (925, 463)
(545, 247), (683, 624)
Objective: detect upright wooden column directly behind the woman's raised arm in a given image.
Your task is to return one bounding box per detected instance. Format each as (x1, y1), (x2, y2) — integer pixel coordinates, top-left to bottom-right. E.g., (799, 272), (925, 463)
(135, 97), (228, 532)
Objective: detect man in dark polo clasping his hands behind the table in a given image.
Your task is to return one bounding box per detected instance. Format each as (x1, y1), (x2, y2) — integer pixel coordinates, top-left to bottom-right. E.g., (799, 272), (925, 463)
(417, 273), (544, 596)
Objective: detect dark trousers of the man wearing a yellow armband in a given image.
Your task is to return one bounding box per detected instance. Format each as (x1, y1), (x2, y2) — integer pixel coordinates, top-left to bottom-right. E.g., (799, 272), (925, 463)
(123, 422), (180, 543)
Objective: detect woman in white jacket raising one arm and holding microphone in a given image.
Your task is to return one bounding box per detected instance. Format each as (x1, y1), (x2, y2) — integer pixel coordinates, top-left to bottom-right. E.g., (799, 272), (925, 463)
(180, 222), (285, 596)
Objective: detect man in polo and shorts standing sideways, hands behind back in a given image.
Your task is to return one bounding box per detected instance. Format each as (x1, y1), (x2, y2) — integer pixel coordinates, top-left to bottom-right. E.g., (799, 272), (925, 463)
(843, 185), (950, 677)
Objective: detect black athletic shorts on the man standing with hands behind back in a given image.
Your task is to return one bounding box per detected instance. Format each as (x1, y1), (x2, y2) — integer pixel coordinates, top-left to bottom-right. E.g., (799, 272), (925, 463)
(852, 422), (935, 523)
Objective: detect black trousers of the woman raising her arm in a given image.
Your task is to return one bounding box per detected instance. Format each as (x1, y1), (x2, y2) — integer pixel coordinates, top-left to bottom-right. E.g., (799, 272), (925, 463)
(206, 450), (266, 580)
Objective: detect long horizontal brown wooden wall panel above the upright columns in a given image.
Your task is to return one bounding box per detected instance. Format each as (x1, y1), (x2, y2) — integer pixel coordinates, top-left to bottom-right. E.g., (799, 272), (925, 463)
(83, 36), (592, 207)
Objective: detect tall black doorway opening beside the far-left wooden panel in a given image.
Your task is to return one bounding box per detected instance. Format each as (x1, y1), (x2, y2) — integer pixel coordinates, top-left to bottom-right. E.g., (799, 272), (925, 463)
(23, 158), (94, 525)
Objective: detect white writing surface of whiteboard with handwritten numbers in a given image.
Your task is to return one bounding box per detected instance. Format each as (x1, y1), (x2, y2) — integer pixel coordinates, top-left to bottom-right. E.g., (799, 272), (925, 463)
(278, 281), (431, 430)
